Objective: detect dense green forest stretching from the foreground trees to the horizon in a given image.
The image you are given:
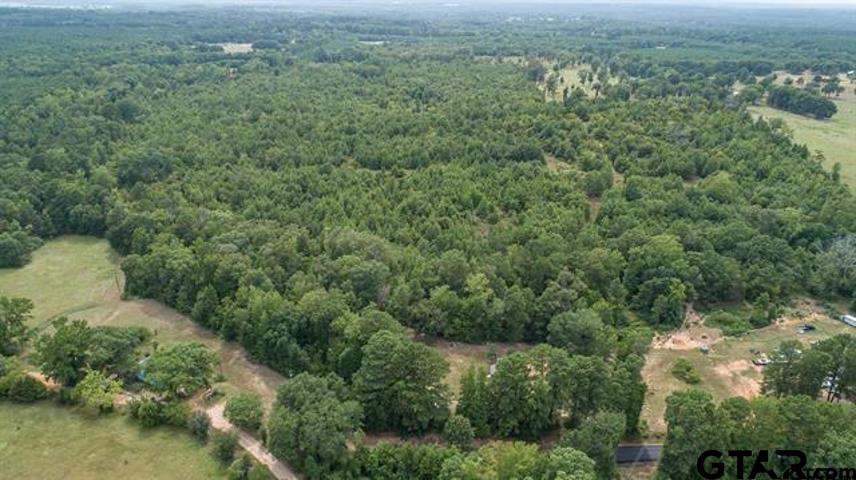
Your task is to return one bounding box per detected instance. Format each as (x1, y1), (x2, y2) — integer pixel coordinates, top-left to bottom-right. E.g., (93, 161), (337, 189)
(0, 9), (856, 480)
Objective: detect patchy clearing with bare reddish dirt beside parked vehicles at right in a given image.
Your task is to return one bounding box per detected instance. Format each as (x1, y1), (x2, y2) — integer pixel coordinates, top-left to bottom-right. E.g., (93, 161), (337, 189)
(642, 304), (853, 437)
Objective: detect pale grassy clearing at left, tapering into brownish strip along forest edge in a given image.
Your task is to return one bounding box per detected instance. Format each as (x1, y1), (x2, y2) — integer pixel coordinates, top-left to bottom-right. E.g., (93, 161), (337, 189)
(0, 236), (284, 405)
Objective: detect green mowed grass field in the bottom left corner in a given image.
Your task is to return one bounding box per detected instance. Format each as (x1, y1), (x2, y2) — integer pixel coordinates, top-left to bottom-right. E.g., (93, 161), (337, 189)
(0, 402), (226, 480)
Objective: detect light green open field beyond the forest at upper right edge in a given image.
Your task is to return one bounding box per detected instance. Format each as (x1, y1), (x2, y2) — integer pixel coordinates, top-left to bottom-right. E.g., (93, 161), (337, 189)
(749, 72), (856, 187)
